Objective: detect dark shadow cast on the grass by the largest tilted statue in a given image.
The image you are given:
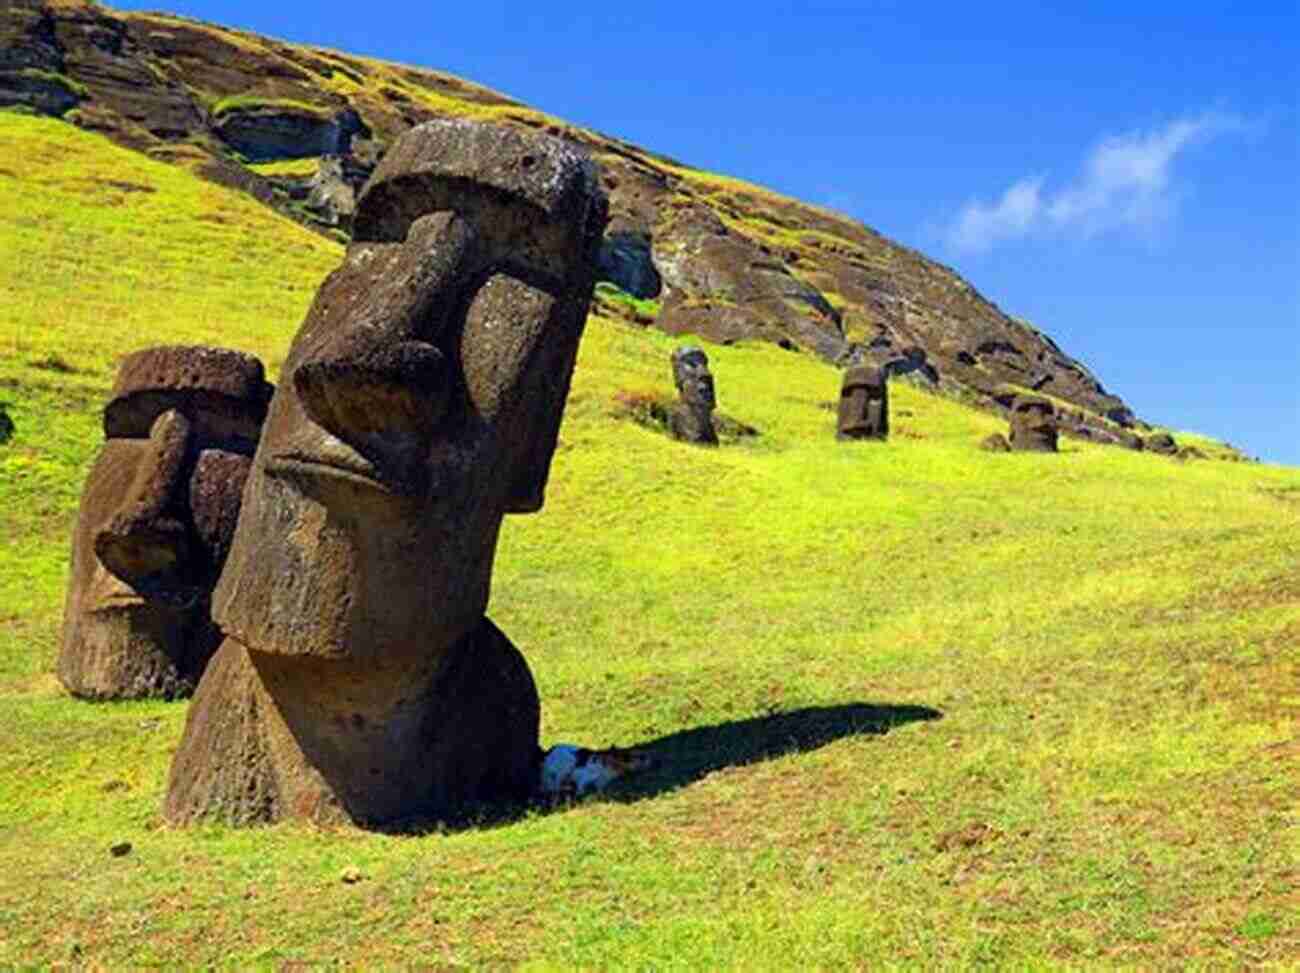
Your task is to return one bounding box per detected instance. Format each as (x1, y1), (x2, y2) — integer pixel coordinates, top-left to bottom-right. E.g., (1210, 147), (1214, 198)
(380, 702), (944, 834)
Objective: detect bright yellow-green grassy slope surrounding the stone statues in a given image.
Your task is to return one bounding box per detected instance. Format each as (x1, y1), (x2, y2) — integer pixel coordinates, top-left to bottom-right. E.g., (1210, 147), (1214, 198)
(0, 113), (1300, 968)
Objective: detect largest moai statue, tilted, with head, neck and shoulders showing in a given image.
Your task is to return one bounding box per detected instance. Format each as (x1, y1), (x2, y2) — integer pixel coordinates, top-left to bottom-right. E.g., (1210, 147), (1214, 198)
(164, 121), (608, 825)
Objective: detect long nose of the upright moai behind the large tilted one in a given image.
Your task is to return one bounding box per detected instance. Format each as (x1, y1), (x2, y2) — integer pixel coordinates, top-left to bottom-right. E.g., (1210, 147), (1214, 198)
(95, 410), (190, 589)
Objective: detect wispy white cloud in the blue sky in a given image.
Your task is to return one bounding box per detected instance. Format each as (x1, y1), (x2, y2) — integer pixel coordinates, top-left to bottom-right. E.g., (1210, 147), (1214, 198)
(948, 112), (1247, 251)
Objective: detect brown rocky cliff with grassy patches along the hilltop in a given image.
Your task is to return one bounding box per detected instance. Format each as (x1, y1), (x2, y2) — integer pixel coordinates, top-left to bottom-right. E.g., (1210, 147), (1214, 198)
(0, 0), (1135, 429)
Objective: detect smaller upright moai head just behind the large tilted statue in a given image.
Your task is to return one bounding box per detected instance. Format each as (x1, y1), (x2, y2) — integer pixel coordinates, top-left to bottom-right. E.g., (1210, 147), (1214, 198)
(59, 346), (270, 700)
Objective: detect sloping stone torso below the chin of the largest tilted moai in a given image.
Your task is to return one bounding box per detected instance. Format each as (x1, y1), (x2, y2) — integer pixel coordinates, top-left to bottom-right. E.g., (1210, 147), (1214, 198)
(163, 618), (541, 825)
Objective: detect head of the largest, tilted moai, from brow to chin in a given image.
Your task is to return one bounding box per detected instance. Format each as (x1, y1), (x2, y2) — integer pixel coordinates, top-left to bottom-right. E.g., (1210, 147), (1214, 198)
(213, 122), (606, 671)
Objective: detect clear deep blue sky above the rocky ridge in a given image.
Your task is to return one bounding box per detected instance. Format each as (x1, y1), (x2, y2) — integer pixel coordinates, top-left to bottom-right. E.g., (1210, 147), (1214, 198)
(113, 0), (1300, 464)
